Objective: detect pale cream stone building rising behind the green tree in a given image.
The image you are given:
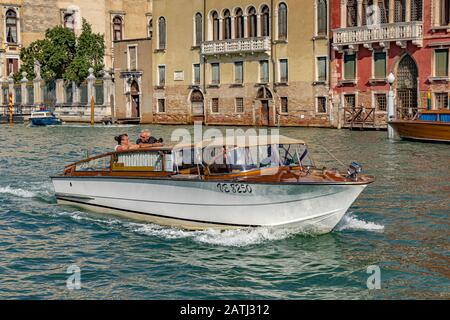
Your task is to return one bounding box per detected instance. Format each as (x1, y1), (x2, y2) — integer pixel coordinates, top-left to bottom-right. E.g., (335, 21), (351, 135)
(0, 0), (152, 78)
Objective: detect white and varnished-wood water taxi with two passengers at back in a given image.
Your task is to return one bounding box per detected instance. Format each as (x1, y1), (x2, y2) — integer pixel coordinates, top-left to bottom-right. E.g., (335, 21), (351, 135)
(51, 136), (374, 234)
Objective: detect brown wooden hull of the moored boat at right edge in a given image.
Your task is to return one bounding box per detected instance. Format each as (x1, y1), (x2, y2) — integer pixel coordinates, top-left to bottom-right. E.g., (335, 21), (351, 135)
(389, 120), (450, 142)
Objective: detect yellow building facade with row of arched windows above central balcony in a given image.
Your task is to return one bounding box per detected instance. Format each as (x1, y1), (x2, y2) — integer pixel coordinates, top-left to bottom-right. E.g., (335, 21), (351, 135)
(150, 0), (333, 127)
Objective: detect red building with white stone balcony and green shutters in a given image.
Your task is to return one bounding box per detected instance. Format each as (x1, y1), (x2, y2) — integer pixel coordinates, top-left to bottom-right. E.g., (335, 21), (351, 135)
(330, 0), (450, 127)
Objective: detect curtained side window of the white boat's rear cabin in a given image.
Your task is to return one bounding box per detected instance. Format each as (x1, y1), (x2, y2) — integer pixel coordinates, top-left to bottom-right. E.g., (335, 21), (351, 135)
(112, 151), (173, 172)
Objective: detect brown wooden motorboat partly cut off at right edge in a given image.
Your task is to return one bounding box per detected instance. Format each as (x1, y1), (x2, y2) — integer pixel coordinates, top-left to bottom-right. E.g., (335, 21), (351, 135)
(389, 110), (450, 142)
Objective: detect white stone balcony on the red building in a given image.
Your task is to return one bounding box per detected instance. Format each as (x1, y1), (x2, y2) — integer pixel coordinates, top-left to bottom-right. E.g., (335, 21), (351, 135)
(333, 22), (423, 51)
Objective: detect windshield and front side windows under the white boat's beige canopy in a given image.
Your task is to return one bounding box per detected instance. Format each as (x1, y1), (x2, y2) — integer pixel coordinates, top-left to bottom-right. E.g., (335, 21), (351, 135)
(203, 144), (314, 174)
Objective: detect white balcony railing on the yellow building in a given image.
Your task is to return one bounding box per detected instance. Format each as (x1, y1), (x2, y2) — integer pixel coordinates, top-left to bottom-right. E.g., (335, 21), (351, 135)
(202, 37), (270, 55)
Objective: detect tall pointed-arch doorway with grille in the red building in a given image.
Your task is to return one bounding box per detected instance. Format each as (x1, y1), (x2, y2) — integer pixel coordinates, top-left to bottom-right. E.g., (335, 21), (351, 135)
(396, 55), (419, 119)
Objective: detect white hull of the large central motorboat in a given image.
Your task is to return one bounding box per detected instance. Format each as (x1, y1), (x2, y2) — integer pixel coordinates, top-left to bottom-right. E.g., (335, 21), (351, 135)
(52, 177), (366, 234)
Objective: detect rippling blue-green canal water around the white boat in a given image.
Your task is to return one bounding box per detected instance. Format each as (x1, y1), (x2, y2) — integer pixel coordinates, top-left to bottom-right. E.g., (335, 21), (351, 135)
(0, 125), (450, 299)
